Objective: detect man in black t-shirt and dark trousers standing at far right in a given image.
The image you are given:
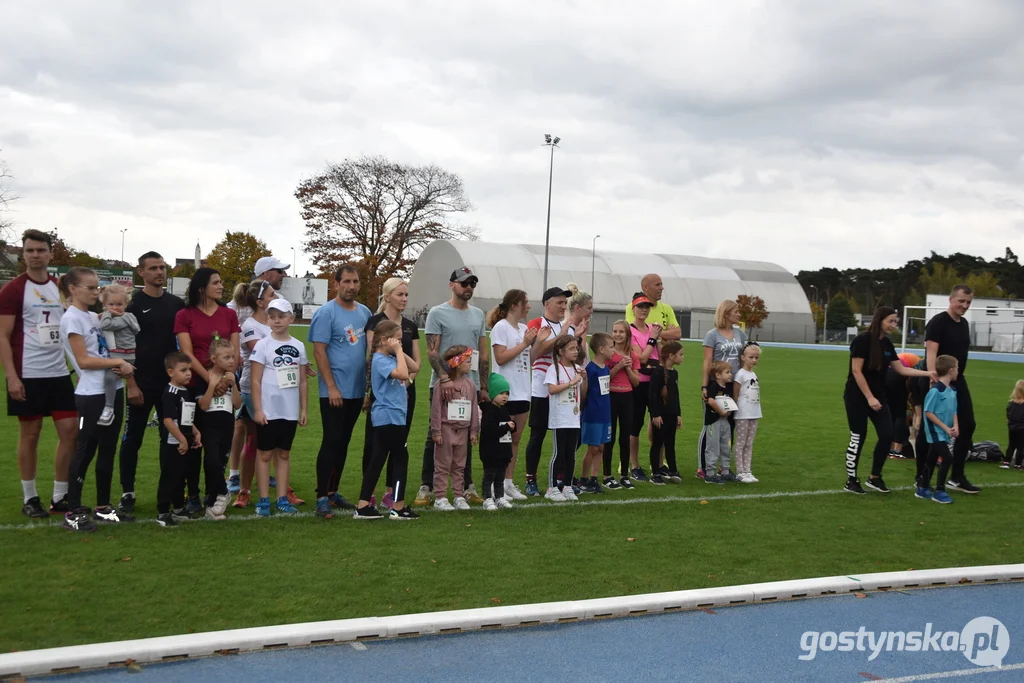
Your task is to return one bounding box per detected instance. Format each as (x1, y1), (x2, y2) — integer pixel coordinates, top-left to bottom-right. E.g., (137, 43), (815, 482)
(925, 285), (980, 494)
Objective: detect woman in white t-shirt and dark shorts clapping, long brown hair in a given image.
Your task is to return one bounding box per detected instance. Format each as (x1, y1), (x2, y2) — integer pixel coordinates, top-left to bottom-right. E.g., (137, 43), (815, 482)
(487, 290), (537, 501)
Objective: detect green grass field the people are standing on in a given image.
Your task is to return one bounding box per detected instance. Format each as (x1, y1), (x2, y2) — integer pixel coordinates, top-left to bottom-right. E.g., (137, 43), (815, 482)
(0, 329), (1024, 651)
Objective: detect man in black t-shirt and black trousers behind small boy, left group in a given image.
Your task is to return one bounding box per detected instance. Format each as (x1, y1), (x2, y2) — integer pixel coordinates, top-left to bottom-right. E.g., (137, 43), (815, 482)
(118, 252), (185, 513)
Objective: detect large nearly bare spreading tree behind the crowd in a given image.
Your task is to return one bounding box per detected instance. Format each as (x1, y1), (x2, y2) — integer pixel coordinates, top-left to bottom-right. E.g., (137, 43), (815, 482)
(295, 157), (477, 299)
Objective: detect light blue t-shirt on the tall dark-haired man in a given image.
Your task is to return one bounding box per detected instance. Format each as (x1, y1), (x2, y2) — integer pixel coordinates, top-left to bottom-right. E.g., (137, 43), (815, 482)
(308, 299), (372, 401)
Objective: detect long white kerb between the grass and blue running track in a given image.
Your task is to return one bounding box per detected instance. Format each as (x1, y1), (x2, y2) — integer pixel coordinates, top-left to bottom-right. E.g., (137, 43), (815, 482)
(0, 564), (1024, 677)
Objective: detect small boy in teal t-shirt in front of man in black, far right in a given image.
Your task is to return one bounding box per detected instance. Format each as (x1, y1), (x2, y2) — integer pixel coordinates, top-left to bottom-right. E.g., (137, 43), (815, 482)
(914, 355), (959, 504)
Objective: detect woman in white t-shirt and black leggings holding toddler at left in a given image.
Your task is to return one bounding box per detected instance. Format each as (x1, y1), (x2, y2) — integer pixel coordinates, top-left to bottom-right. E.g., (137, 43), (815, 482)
(59, 266), (135, 531)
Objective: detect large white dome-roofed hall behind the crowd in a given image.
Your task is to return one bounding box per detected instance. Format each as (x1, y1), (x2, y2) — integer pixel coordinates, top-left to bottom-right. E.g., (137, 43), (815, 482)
(407, 240), (815, 342)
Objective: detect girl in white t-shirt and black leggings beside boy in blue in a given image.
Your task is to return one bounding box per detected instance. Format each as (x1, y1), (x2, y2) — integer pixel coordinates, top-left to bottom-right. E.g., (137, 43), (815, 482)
(544, 336), (587, 502)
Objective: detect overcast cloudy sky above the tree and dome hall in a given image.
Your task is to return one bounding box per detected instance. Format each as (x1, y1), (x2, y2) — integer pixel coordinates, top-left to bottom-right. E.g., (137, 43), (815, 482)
(0, 0), (1024, 271)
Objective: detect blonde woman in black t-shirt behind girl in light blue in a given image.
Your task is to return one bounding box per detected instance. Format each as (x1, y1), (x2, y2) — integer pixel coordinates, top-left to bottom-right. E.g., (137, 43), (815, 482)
(362, 278), (420, 510)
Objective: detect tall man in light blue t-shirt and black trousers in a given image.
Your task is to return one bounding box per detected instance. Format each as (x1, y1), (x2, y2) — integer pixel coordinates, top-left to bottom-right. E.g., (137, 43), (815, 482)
(309, 263), (371, 510)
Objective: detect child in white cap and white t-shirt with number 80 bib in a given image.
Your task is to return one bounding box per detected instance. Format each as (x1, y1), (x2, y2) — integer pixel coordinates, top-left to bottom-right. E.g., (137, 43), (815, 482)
(249, 299), (309, 517)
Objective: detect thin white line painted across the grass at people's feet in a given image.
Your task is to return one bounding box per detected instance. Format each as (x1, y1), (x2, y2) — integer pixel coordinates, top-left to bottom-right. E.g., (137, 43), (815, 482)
(0, 481), (1024, 533)
